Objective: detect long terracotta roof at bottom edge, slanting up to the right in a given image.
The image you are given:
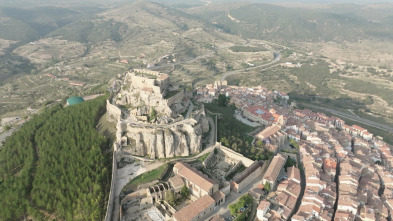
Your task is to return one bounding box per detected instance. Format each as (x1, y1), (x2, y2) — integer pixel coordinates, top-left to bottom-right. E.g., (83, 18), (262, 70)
(174, 195), (216, 221)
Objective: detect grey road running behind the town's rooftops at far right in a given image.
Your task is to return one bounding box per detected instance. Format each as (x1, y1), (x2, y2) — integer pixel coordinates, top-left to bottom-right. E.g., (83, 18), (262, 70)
(302, 103), (393, 133)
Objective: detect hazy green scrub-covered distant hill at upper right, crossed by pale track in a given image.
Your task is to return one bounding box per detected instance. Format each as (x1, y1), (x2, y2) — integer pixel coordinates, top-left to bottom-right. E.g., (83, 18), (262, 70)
(189, 4), (393, 43)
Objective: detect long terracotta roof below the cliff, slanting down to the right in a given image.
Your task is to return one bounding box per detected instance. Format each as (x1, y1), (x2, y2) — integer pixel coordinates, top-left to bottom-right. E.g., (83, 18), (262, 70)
(174, 162), (218, 192)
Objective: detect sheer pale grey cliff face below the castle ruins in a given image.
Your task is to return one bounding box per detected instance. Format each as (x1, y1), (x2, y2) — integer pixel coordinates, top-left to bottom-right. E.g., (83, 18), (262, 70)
(122, 115), (206, 158)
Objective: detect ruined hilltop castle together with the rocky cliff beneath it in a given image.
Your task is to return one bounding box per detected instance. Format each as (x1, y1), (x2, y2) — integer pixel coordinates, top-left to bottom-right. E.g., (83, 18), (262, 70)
(107, 69), (209, 159)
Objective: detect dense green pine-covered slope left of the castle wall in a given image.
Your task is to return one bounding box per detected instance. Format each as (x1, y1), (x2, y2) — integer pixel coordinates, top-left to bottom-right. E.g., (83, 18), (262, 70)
(0, 97), (111, 220)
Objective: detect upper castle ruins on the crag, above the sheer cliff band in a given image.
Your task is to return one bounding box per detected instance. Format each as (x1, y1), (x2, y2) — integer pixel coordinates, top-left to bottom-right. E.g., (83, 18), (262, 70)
(115, 69), (189, 123)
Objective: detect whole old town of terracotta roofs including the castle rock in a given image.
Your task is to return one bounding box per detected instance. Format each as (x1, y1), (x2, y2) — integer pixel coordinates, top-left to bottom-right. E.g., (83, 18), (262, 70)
(102, 69), (393, 221)
